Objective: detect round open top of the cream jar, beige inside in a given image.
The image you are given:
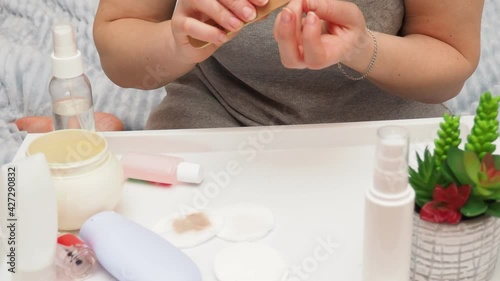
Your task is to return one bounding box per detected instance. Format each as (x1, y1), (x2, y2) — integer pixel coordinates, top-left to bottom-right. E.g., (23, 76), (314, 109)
(26, 129), (107, 169)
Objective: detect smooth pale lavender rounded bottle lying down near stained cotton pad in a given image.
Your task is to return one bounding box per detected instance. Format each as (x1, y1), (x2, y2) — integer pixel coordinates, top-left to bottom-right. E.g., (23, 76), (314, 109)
(80, 211), (202, 281)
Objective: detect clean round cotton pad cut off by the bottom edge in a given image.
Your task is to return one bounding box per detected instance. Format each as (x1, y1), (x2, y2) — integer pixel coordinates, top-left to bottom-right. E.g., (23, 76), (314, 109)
(214, 242), (287, 281)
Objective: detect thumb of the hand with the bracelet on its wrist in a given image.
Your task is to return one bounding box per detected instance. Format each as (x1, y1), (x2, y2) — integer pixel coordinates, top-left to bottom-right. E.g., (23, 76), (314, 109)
(306, 0), (365, 28)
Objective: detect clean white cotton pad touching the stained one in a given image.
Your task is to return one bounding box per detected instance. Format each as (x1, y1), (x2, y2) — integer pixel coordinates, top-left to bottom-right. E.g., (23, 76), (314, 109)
(217, 203), (275, 242)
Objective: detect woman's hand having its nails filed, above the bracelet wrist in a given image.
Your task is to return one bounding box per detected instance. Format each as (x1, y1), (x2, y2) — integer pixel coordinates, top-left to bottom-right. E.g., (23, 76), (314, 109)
(274, 0), (373, 69)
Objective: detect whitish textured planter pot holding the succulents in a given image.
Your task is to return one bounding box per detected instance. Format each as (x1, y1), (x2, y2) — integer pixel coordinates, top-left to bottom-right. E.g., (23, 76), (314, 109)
(410, 214), (500, 281)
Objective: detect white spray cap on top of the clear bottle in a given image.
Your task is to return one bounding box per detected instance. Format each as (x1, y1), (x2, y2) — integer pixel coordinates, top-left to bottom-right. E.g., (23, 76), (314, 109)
(52, 24), (83, 79)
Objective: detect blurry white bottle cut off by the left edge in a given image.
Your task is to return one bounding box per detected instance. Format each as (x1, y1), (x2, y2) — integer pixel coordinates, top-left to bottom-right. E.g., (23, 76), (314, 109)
(0, 153), (57, 281)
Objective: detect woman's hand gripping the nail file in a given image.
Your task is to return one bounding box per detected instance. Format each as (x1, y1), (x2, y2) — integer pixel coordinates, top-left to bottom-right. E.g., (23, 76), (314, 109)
(172, 0), (268, 63)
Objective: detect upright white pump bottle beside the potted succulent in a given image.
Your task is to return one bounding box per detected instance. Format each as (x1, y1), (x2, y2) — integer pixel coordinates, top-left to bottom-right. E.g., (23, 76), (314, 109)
(363, 126), (415, 281)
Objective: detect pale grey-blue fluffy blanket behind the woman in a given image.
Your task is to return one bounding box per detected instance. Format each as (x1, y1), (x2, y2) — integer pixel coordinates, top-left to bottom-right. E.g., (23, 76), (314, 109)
(0, 0), (500, 165)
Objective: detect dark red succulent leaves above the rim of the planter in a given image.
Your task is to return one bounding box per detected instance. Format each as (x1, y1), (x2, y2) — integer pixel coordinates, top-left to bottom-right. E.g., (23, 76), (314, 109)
(420, 183), (471, 224)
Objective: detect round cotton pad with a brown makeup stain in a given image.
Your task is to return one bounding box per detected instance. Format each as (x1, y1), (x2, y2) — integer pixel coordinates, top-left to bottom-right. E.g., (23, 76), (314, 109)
(153, 211), (224, 248)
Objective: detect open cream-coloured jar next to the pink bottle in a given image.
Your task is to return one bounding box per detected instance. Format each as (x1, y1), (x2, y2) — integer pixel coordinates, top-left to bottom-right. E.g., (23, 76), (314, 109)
(27, 129), (125, 231)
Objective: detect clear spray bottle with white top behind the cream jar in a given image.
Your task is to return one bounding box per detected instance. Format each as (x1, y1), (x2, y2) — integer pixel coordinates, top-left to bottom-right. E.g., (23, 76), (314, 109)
(49, 24), (95, 131)
